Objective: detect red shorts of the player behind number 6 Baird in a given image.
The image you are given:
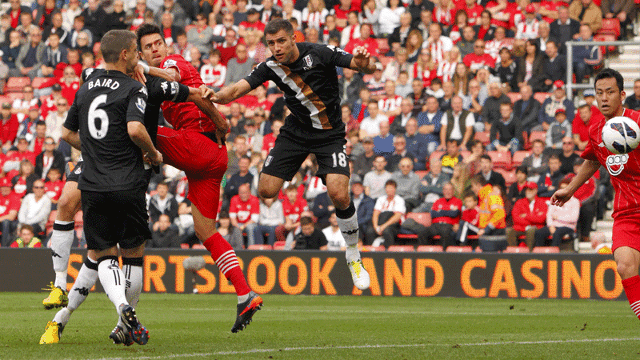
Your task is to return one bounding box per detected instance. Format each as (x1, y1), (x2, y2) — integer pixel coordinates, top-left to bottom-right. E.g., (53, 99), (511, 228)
(157, 126), (228, 219)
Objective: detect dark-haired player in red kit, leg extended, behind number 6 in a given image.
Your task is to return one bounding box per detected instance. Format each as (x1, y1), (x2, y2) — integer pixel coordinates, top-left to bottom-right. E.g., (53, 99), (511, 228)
(137, 24), (262, 333)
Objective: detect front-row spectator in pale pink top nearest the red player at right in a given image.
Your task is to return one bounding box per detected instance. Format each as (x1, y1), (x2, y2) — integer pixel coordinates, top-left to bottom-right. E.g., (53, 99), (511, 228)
(535, 179), (580, 246)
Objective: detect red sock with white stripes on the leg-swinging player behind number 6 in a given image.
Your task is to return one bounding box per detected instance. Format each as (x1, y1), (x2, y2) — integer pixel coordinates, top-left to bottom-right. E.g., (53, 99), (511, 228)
(204, 232), (251, 296)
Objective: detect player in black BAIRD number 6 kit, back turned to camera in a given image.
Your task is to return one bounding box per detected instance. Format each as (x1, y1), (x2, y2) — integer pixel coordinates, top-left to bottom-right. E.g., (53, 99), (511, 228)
(49, 30), (162, 345)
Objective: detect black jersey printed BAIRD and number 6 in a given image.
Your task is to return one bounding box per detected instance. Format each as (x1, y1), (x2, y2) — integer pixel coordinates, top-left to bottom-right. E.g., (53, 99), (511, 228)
(64, 70), (147, 192)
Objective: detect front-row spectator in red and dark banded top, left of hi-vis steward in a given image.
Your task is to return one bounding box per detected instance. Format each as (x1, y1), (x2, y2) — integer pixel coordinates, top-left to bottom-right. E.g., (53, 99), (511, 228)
(420, 183), (462, 250)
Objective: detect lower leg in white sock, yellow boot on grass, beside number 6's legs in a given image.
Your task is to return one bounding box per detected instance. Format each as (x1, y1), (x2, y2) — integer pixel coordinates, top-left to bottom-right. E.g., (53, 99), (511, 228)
(40, 252), (98, 344)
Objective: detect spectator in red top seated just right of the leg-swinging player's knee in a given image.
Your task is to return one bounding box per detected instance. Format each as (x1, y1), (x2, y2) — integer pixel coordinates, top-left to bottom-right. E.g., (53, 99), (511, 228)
(229, 184), (260, 246)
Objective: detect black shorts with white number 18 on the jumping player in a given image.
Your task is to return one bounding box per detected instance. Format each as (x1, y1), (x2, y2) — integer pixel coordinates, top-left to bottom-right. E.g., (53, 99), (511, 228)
(262, 128), (351, 181)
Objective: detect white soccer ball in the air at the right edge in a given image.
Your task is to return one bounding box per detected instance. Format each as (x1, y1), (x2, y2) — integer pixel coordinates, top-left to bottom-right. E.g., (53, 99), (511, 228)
(602, 116), (640, 154)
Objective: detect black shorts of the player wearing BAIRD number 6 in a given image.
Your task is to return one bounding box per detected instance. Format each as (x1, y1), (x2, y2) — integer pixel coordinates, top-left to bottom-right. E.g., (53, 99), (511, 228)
(81, 189), (151, 250)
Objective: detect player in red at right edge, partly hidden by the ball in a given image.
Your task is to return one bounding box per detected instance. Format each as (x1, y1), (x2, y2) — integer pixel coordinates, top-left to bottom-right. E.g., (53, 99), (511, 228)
(551, 69), (640, 319)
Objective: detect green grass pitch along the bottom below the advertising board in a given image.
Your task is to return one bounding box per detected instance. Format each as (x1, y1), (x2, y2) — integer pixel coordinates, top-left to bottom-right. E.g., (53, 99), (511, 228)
(0, 293), (640, 359)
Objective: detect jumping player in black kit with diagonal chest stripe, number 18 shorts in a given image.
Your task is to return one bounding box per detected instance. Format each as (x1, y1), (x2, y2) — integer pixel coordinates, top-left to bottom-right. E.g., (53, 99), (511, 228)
(212, 19), (376, 290)
